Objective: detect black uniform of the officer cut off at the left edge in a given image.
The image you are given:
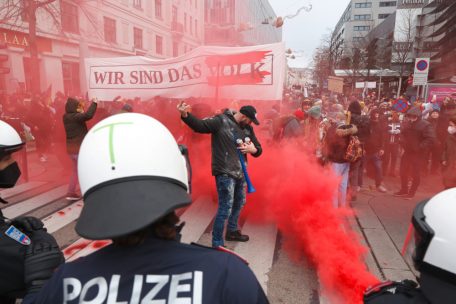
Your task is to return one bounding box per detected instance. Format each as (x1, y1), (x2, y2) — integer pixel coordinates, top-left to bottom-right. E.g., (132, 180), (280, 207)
(0, 210), (26, 304)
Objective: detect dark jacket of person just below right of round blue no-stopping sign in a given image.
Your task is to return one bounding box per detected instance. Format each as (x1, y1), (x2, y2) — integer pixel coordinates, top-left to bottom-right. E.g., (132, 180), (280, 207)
(401, 118), (436, 155)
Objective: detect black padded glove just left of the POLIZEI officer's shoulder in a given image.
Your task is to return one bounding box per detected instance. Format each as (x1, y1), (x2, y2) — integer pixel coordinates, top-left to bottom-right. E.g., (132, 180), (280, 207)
(11, 217), (65, 293)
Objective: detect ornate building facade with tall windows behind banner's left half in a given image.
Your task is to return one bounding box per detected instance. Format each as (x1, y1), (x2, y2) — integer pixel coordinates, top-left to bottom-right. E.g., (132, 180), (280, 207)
(0, 0), (204, 95)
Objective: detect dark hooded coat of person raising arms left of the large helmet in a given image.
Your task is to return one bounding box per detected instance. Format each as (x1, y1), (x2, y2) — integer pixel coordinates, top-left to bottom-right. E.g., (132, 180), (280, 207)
(63, 98), (97, 154)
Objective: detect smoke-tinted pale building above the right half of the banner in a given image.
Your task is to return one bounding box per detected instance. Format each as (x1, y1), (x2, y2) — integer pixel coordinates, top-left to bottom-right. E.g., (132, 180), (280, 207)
(205, 0), (282, 46)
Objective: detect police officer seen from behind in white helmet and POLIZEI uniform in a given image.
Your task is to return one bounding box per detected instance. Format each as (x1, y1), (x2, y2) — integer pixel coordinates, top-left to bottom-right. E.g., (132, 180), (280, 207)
(24, 113), (268, 304)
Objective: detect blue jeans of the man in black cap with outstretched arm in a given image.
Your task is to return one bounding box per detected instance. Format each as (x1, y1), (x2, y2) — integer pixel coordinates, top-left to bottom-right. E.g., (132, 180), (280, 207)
(212, 174), (246, 247)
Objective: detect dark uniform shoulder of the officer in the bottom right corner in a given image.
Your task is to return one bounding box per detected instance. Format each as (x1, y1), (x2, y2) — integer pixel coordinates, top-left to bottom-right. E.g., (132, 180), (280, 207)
(364, 280), (431, 304)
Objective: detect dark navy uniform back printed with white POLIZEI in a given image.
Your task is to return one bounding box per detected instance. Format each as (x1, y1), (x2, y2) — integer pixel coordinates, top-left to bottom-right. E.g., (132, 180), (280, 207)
(23, 237), (269, 304)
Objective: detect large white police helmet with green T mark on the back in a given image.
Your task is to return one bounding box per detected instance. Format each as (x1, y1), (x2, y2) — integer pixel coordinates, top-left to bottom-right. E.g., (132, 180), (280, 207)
(76, 113), (191, 239)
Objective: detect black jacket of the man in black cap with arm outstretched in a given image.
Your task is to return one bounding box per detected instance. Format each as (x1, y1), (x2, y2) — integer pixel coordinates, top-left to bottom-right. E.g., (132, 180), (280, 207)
(182, 110), (263, 179)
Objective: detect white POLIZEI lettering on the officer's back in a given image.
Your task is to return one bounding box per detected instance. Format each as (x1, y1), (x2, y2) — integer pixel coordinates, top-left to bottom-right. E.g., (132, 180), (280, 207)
(63, 271), (203, 304)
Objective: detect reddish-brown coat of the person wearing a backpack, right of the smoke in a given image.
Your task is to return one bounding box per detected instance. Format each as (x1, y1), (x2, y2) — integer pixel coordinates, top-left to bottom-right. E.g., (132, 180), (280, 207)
(324, 124), (358, 163)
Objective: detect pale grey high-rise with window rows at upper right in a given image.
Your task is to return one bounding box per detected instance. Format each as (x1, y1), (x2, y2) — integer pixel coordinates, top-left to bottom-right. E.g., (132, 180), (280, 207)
(332, 0), (397, 51)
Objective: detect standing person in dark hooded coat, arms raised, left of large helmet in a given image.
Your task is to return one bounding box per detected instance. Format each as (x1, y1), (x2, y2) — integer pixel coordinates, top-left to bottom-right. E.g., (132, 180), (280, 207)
(63, 97), (98, 200)
